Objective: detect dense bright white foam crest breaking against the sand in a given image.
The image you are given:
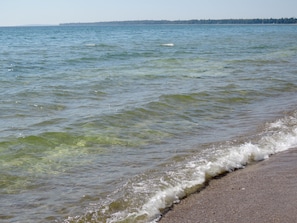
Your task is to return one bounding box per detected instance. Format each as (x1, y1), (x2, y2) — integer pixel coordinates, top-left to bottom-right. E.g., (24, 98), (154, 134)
(141, 114), (297, 222)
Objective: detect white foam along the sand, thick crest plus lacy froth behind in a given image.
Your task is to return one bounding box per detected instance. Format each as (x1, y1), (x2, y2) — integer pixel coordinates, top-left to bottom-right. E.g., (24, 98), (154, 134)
(84, 113), (297, 222)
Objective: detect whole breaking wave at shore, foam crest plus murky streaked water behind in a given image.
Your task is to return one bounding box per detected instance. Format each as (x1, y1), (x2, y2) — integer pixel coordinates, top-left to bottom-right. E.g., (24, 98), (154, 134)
(65, 111), (297, 223)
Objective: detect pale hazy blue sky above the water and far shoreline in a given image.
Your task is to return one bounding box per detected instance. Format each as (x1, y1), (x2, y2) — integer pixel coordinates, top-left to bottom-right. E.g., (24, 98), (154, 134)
(0, 0), (297, 26)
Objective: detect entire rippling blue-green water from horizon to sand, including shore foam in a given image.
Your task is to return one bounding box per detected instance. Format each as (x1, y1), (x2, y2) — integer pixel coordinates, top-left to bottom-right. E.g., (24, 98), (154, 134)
(0, 25), (297, 222)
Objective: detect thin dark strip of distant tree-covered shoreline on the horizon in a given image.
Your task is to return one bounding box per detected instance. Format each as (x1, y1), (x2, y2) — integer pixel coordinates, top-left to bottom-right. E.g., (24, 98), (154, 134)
(60, 18), (297, 26)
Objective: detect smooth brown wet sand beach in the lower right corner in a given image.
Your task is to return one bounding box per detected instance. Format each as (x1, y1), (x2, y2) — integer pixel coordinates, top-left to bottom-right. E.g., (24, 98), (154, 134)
(160, 148), (297, 223)
